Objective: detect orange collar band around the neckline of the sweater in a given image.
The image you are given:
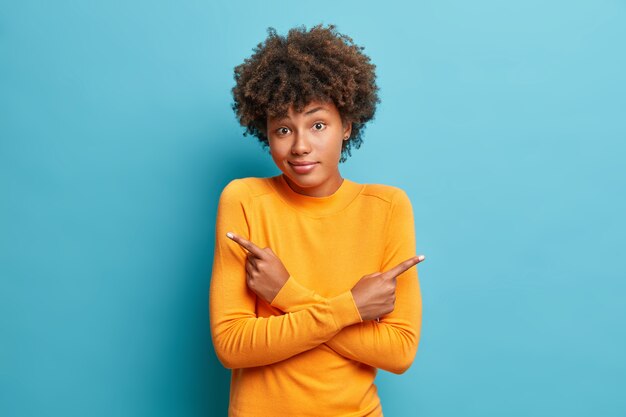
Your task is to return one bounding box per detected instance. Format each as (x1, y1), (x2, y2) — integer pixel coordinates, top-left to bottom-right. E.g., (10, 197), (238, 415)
(269, 174), (364, 217)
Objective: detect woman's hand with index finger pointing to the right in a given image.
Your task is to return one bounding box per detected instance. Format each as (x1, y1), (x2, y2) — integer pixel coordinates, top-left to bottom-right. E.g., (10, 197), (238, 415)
(352, 255), (424, 320)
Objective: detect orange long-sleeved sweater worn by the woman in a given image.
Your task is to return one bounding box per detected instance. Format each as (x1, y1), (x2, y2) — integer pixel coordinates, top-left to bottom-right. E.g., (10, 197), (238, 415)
(209, 175), (422, 417)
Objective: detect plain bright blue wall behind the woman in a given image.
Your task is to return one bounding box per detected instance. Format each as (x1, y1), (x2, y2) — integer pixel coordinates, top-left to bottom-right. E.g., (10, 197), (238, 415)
(0, 0), (626, 417)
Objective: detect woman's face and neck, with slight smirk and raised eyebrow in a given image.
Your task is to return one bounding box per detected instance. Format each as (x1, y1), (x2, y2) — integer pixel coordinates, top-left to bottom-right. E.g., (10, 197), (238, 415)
(267, 101), (352, 197)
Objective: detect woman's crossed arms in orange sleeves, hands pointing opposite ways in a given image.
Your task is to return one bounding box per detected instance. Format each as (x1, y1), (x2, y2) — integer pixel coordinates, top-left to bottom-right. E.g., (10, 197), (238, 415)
(210, 182), (421, 373)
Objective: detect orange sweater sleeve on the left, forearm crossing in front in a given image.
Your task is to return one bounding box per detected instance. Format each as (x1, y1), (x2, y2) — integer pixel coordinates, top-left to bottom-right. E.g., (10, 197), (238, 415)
(209, 180), (361, 368)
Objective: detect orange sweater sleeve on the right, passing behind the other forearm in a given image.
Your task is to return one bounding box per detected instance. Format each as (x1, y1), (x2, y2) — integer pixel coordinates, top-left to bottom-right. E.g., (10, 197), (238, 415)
(272, 190), (422, 374)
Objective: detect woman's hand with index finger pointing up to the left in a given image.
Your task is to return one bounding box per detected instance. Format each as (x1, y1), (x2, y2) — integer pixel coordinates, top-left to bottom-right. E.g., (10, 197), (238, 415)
(226, 232), (289, 303)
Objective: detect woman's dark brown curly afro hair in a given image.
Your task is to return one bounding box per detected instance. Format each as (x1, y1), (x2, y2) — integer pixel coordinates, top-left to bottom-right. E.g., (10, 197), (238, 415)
(232, 24), (380, 162)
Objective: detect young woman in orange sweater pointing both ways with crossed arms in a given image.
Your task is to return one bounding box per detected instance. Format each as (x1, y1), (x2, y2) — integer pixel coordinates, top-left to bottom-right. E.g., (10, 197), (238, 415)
(209, 25), (424, 417)
